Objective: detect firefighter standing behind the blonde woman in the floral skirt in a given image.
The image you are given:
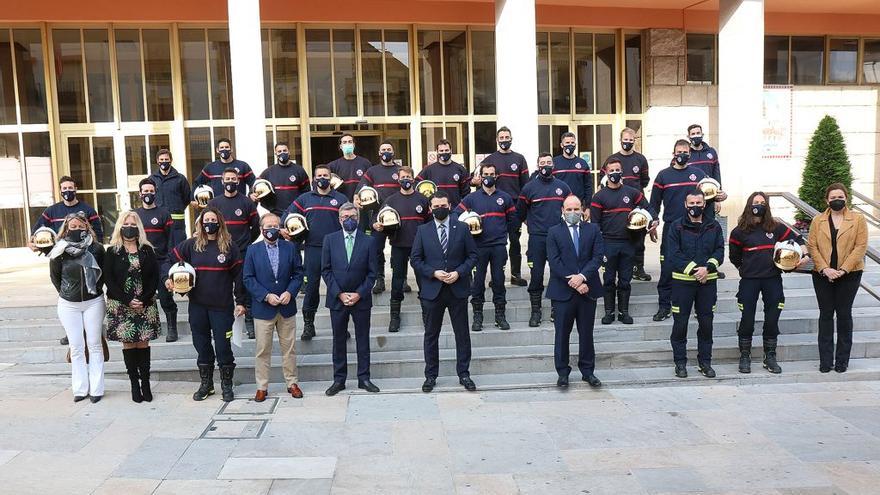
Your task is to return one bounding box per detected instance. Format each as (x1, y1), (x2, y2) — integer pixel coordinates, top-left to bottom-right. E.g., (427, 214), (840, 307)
(134, 178), (177, 342)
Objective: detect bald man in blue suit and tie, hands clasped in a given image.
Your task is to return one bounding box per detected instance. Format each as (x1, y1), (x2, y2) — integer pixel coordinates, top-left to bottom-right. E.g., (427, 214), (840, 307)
(546, 196), (605, 387)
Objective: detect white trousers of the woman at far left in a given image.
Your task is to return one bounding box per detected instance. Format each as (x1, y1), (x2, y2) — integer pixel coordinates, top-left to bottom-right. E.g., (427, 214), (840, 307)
(58, 296), (106, 397)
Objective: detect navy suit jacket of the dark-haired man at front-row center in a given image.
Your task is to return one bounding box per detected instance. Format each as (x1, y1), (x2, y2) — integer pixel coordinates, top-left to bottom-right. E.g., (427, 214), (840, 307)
(409, 220), (477, 301)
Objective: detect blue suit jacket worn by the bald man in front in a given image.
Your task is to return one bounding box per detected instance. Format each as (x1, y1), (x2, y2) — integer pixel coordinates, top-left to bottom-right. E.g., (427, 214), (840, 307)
(545, 222), (605, 301)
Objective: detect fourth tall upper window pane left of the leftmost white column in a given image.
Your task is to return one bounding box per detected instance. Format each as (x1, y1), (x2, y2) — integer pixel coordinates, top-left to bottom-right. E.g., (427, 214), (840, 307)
(115, 29), (144, 121)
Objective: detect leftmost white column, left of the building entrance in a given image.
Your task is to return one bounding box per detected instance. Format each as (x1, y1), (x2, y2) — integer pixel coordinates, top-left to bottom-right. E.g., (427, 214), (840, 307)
(227, 0), (268, 174)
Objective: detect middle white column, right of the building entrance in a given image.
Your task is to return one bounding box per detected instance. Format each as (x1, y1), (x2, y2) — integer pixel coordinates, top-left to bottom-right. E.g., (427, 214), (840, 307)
(495, 0), (549, 170)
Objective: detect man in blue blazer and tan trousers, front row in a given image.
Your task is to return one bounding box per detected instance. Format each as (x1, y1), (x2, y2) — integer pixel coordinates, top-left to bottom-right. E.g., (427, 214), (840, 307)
(243, 213), (303, 402)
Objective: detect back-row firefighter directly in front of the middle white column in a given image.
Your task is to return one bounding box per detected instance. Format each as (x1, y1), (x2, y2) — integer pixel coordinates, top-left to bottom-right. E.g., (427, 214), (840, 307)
(482, 127), (529, 287)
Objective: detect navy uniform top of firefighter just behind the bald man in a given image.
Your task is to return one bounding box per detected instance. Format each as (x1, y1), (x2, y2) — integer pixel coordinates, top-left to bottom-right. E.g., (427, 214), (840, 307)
(516, 176), (572, 235)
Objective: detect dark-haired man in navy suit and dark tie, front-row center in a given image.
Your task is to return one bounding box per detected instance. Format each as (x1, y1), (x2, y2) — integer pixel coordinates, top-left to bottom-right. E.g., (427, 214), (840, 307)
(410, 190), (477, 393)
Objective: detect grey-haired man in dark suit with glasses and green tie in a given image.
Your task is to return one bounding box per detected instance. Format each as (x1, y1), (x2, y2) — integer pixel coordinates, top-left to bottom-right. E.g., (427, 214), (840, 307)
(321, 202), (379, 396)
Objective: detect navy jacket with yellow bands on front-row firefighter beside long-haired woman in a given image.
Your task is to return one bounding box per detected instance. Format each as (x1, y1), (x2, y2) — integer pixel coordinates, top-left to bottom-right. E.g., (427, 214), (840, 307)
(666, 216), (724, 283)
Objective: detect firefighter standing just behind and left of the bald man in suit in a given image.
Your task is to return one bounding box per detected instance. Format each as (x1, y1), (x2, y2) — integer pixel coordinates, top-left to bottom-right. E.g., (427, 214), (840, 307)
(517, 153), (573, 327)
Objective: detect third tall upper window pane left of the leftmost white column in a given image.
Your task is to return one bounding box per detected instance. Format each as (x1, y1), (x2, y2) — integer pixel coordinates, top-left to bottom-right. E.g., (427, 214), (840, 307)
(141, 29), (174, 121)
